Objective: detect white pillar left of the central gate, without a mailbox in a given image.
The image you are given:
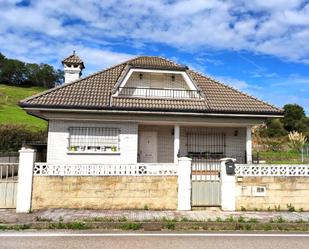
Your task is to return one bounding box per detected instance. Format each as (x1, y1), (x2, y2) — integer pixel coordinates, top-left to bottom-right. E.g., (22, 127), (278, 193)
(177, 157), (192, 210)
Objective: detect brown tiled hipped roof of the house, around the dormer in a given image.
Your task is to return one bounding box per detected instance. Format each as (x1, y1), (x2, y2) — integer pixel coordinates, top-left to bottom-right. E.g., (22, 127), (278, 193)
(20, 56), (282, 114)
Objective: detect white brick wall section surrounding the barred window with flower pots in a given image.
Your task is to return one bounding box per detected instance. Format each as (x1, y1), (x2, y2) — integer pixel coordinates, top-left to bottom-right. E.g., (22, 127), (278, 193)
(47, 120), (138, 164)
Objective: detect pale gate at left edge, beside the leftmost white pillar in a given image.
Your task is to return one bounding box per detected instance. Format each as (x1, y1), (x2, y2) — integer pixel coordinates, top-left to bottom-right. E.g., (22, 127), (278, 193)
(0, 163), (18, 208)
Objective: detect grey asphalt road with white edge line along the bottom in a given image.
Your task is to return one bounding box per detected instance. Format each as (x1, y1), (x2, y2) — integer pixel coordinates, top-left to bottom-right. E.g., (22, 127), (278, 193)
(0, 232), (309, 249)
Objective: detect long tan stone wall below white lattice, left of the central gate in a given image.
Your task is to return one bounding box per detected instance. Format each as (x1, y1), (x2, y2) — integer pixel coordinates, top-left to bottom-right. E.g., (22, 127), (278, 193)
(32, 176), (177, 210)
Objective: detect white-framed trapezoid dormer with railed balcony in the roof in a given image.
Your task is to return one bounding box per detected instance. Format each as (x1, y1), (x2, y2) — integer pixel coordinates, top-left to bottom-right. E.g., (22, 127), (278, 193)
(113, 69), (202, 99)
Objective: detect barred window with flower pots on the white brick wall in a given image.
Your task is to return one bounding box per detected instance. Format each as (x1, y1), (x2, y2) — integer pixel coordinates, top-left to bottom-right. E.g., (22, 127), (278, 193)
(68, 127), (120, 153)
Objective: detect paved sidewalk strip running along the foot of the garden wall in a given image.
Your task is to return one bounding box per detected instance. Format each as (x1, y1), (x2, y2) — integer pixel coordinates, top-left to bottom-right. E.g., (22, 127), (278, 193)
(0, 209), (309, 224)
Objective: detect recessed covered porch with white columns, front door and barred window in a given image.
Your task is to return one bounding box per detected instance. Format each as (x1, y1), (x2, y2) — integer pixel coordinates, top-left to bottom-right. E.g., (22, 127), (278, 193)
(137, 123), (252, 165)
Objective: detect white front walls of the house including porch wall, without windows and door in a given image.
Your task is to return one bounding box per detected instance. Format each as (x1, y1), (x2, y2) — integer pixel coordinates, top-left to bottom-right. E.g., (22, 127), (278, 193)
(47, 120), (251, 164)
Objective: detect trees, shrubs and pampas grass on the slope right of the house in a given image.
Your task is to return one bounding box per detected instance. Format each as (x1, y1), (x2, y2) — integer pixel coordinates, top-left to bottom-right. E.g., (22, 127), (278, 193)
(253, 104), (309, 163)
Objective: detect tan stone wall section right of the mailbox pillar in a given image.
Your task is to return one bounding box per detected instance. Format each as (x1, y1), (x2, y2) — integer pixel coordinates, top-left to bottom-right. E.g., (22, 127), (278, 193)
(236, 176), (309, 211)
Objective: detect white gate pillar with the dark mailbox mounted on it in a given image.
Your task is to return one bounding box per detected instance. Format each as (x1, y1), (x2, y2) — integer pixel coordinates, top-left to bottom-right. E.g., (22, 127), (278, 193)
(220, 158), (236, 211)
